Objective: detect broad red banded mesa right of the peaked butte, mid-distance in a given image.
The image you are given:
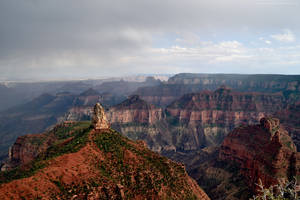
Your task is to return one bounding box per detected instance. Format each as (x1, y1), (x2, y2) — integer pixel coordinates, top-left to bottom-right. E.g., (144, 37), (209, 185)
(166, 87), (285, 146)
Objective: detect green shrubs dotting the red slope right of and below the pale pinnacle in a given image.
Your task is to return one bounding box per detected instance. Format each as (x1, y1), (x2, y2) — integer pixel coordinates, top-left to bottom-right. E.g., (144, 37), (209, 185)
(94, 130), (194, 199)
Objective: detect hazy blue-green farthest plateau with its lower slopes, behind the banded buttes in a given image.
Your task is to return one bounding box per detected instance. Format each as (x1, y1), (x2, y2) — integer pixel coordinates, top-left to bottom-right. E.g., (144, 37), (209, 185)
(135, 74), (300, 107)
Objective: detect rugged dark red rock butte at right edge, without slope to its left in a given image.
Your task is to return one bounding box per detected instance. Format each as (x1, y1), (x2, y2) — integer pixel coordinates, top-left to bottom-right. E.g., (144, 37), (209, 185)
(219, 118), (300, 190)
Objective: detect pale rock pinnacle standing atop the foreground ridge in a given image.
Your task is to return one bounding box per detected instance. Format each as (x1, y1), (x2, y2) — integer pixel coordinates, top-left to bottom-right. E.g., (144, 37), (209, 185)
(92, 103), (110, 130)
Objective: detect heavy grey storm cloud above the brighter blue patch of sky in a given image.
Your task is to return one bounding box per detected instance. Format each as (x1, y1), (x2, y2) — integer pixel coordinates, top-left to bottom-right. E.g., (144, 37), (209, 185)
(0, 0), (300, 78)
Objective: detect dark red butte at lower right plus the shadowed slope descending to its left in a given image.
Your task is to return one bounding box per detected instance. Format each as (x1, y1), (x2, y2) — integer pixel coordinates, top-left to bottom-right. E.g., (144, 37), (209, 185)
(173, 118), (300, 200)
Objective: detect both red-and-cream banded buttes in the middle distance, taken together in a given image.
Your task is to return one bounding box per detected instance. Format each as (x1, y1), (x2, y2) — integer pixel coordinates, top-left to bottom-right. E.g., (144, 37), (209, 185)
(104, 87), (286, 152)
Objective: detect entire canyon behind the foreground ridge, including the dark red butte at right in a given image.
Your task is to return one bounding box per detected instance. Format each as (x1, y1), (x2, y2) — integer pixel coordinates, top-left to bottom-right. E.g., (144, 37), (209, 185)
(0, 74), (300, 200)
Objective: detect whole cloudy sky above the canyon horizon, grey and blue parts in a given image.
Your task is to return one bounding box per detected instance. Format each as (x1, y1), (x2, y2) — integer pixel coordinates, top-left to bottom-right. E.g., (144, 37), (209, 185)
(0, 0), (300, 81)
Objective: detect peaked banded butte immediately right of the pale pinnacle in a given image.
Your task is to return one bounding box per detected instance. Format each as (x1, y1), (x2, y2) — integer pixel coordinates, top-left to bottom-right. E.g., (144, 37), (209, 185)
(107, 95), (170, 152)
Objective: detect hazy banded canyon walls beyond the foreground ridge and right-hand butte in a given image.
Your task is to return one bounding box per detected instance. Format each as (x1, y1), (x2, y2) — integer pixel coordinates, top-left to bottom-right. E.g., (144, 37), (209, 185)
(0, 74), (300, 159)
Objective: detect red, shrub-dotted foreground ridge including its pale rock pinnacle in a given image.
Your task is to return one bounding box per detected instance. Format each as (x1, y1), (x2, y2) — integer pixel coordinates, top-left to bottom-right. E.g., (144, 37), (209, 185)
(0, 105), (209, 200)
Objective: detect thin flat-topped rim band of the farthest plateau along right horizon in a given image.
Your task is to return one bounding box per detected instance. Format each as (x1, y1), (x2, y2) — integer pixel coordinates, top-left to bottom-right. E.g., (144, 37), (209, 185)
(168, 73), (300, 92)
